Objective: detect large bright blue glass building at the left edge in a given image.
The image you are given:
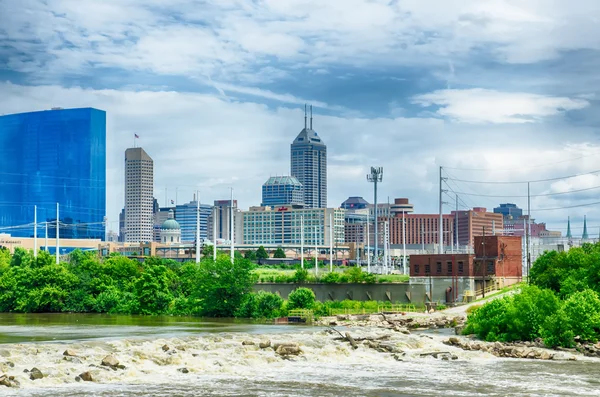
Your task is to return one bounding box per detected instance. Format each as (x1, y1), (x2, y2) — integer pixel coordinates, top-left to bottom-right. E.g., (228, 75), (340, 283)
(0, 108), (106, 239)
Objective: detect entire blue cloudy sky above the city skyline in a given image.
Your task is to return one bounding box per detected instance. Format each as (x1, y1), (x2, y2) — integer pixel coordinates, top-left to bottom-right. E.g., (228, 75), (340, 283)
(0, 0), (600, 235)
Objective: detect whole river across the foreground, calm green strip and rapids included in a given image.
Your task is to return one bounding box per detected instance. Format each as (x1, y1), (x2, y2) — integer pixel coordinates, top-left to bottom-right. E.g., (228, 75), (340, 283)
(0, 314), (600, 397)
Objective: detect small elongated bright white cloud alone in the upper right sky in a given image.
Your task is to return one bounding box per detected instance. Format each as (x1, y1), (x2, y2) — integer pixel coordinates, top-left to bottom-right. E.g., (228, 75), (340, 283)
(413, 88), (589, 123)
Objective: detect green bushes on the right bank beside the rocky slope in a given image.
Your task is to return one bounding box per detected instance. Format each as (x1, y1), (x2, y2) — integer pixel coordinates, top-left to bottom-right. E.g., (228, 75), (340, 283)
(464, 244), (600, 347)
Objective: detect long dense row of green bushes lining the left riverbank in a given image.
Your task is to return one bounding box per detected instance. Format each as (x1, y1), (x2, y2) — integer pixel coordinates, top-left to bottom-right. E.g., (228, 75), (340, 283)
(0, 249), (255, 316)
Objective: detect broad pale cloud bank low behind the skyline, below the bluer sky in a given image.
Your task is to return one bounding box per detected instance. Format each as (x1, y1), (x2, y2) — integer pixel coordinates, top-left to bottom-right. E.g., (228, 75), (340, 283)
(0, 83), (600, 232)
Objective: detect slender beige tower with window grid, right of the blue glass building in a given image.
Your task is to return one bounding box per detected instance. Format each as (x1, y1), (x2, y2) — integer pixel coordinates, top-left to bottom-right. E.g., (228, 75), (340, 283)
(125, 148), (154, 242)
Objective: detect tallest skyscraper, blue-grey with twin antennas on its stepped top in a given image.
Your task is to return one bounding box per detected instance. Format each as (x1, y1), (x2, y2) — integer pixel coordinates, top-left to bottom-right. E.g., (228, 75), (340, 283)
(291, 106), (327, 208)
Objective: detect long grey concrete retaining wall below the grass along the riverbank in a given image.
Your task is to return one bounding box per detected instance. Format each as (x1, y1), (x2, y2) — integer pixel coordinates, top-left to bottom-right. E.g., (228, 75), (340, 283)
(254, 283), (425, 306)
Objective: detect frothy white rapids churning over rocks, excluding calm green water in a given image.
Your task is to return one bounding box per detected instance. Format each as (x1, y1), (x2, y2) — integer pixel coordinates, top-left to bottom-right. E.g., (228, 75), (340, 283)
(0, 328), (598, 396)
